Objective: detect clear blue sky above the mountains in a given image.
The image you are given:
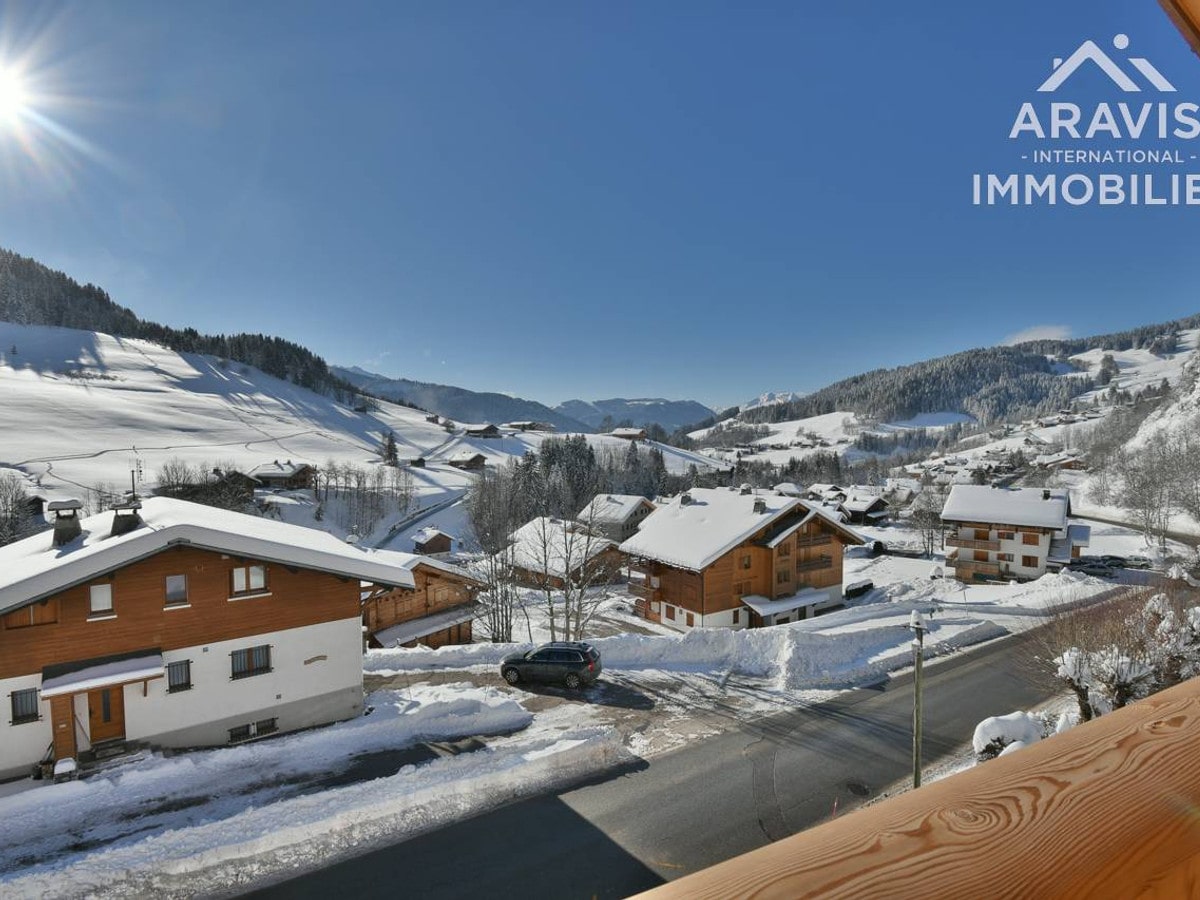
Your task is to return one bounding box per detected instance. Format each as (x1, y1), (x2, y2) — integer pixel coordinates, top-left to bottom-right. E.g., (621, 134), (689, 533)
(0, 0), (1200, 406)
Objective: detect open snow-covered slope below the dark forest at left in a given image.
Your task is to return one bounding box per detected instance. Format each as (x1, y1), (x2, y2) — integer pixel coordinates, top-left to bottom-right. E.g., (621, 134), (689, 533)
(0, 323), (716, 505)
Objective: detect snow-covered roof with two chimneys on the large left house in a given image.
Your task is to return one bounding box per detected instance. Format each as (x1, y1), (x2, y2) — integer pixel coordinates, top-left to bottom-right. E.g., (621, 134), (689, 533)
(0, 497), (430, 613)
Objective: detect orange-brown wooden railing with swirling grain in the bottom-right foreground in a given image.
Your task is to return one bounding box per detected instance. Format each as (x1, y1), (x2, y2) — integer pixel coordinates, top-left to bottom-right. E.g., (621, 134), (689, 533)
(644, 679), (1200, 900)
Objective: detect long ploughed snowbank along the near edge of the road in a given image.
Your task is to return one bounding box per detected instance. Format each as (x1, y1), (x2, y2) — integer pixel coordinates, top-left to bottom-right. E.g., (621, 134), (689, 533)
(2, 726), (628, 899)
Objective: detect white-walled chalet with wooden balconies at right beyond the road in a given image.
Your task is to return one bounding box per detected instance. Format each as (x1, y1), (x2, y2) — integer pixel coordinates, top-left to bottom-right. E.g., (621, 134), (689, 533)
(942, 485), (1091, 582)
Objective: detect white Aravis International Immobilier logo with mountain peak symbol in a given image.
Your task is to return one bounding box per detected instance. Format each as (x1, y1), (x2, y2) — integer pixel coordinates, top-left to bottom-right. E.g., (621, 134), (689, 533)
(972, 34), (1200, 208)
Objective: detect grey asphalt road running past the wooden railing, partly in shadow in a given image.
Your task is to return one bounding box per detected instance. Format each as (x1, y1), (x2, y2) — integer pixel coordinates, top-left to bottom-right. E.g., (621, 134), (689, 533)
(256, 634), (1061, 900)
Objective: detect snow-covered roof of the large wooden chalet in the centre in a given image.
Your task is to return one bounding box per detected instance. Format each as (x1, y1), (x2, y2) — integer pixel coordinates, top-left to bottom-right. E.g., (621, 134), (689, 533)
(620, 487), (862, 571)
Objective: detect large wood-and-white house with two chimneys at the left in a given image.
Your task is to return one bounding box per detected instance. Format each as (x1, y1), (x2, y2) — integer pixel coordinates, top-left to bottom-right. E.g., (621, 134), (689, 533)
(0, 497), (416, 779)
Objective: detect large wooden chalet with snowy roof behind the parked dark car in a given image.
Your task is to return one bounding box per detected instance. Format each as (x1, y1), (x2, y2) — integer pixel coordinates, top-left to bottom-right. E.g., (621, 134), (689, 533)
(620, 486), (865, 631)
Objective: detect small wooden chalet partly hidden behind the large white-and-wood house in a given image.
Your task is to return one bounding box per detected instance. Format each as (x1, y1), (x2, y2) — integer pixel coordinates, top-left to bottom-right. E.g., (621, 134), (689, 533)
(362, 554), (484, 647)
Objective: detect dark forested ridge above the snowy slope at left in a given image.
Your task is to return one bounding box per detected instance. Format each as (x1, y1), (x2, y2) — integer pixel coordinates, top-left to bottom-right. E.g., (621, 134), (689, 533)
(0, 247), (356, 400)
